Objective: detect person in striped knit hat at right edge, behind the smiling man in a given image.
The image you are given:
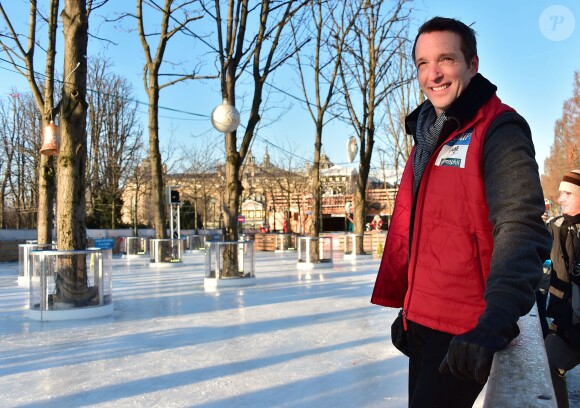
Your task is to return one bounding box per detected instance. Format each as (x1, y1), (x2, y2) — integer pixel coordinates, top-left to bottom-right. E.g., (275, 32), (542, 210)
(545, 170), (580, 408)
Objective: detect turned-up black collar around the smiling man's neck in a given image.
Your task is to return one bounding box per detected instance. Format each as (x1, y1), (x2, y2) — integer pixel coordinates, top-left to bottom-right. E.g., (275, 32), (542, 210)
(405, 73), (497, 135)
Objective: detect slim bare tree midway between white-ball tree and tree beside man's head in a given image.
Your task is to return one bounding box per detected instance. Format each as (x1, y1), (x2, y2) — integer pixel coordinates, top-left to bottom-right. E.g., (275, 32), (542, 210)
(294, 0), (360, 244)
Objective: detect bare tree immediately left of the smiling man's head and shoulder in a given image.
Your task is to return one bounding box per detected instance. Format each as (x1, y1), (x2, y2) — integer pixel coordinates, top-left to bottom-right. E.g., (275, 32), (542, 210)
(340, 0), (410, 252)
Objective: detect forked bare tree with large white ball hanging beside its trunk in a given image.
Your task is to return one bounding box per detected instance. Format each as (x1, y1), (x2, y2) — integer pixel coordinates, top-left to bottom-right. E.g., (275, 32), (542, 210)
(208, 0), (308, 276)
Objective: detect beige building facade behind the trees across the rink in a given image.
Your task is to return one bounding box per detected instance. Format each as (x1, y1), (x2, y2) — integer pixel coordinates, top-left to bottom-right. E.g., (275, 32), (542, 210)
(122, 149), (397, 234)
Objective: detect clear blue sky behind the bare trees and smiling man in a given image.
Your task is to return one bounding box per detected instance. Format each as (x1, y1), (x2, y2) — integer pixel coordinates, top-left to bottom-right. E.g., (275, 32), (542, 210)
(0, 0), (580, 176)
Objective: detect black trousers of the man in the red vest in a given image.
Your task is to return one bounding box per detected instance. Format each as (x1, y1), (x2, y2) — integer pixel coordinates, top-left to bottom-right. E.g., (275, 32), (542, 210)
(407, 321), (483, 408)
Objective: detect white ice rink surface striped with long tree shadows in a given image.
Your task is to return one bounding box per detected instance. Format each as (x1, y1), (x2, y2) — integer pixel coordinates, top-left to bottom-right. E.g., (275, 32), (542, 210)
(0, 252), (576, 408)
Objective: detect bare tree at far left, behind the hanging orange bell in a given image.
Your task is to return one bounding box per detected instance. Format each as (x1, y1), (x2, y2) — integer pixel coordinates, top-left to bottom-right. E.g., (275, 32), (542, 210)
(0, 0), (59, 244)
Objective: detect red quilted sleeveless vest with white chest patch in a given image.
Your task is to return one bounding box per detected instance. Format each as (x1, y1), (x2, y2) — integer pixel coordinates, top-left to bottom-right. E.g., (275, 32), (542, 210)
(371, 95), (513, 335)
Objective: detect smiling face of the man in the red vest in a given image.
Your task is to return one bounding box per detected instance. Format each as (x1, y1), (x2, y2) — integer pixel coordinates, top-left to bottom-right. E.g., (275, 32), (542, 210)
(415, 31), (479, 116)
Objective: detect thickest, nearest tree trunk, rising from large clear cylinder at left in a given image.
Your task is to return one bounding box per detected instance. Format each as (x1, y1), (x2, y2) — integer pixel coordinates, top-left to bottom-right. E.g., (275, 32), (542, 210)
(57, 0), (95, 303)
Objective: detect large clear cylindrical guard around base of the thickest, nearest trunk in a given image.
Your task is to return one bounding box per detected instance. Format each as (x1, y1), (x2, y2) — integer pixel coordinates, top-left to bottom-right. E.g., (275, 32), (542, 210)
(29, 248), (113, 321)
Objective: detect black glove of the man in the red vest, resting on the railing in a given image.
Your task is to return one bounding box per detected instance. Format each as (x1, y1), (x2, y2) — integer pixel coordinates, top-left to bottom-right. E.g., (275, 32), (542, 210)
(439, 311), (520, 384)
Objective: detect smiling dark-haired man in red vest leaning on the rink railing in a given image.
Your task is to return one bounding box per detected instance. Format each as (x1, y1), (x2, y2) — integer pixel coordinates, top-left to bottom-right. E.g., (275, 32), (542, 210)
(371, 17), (551, 408)
